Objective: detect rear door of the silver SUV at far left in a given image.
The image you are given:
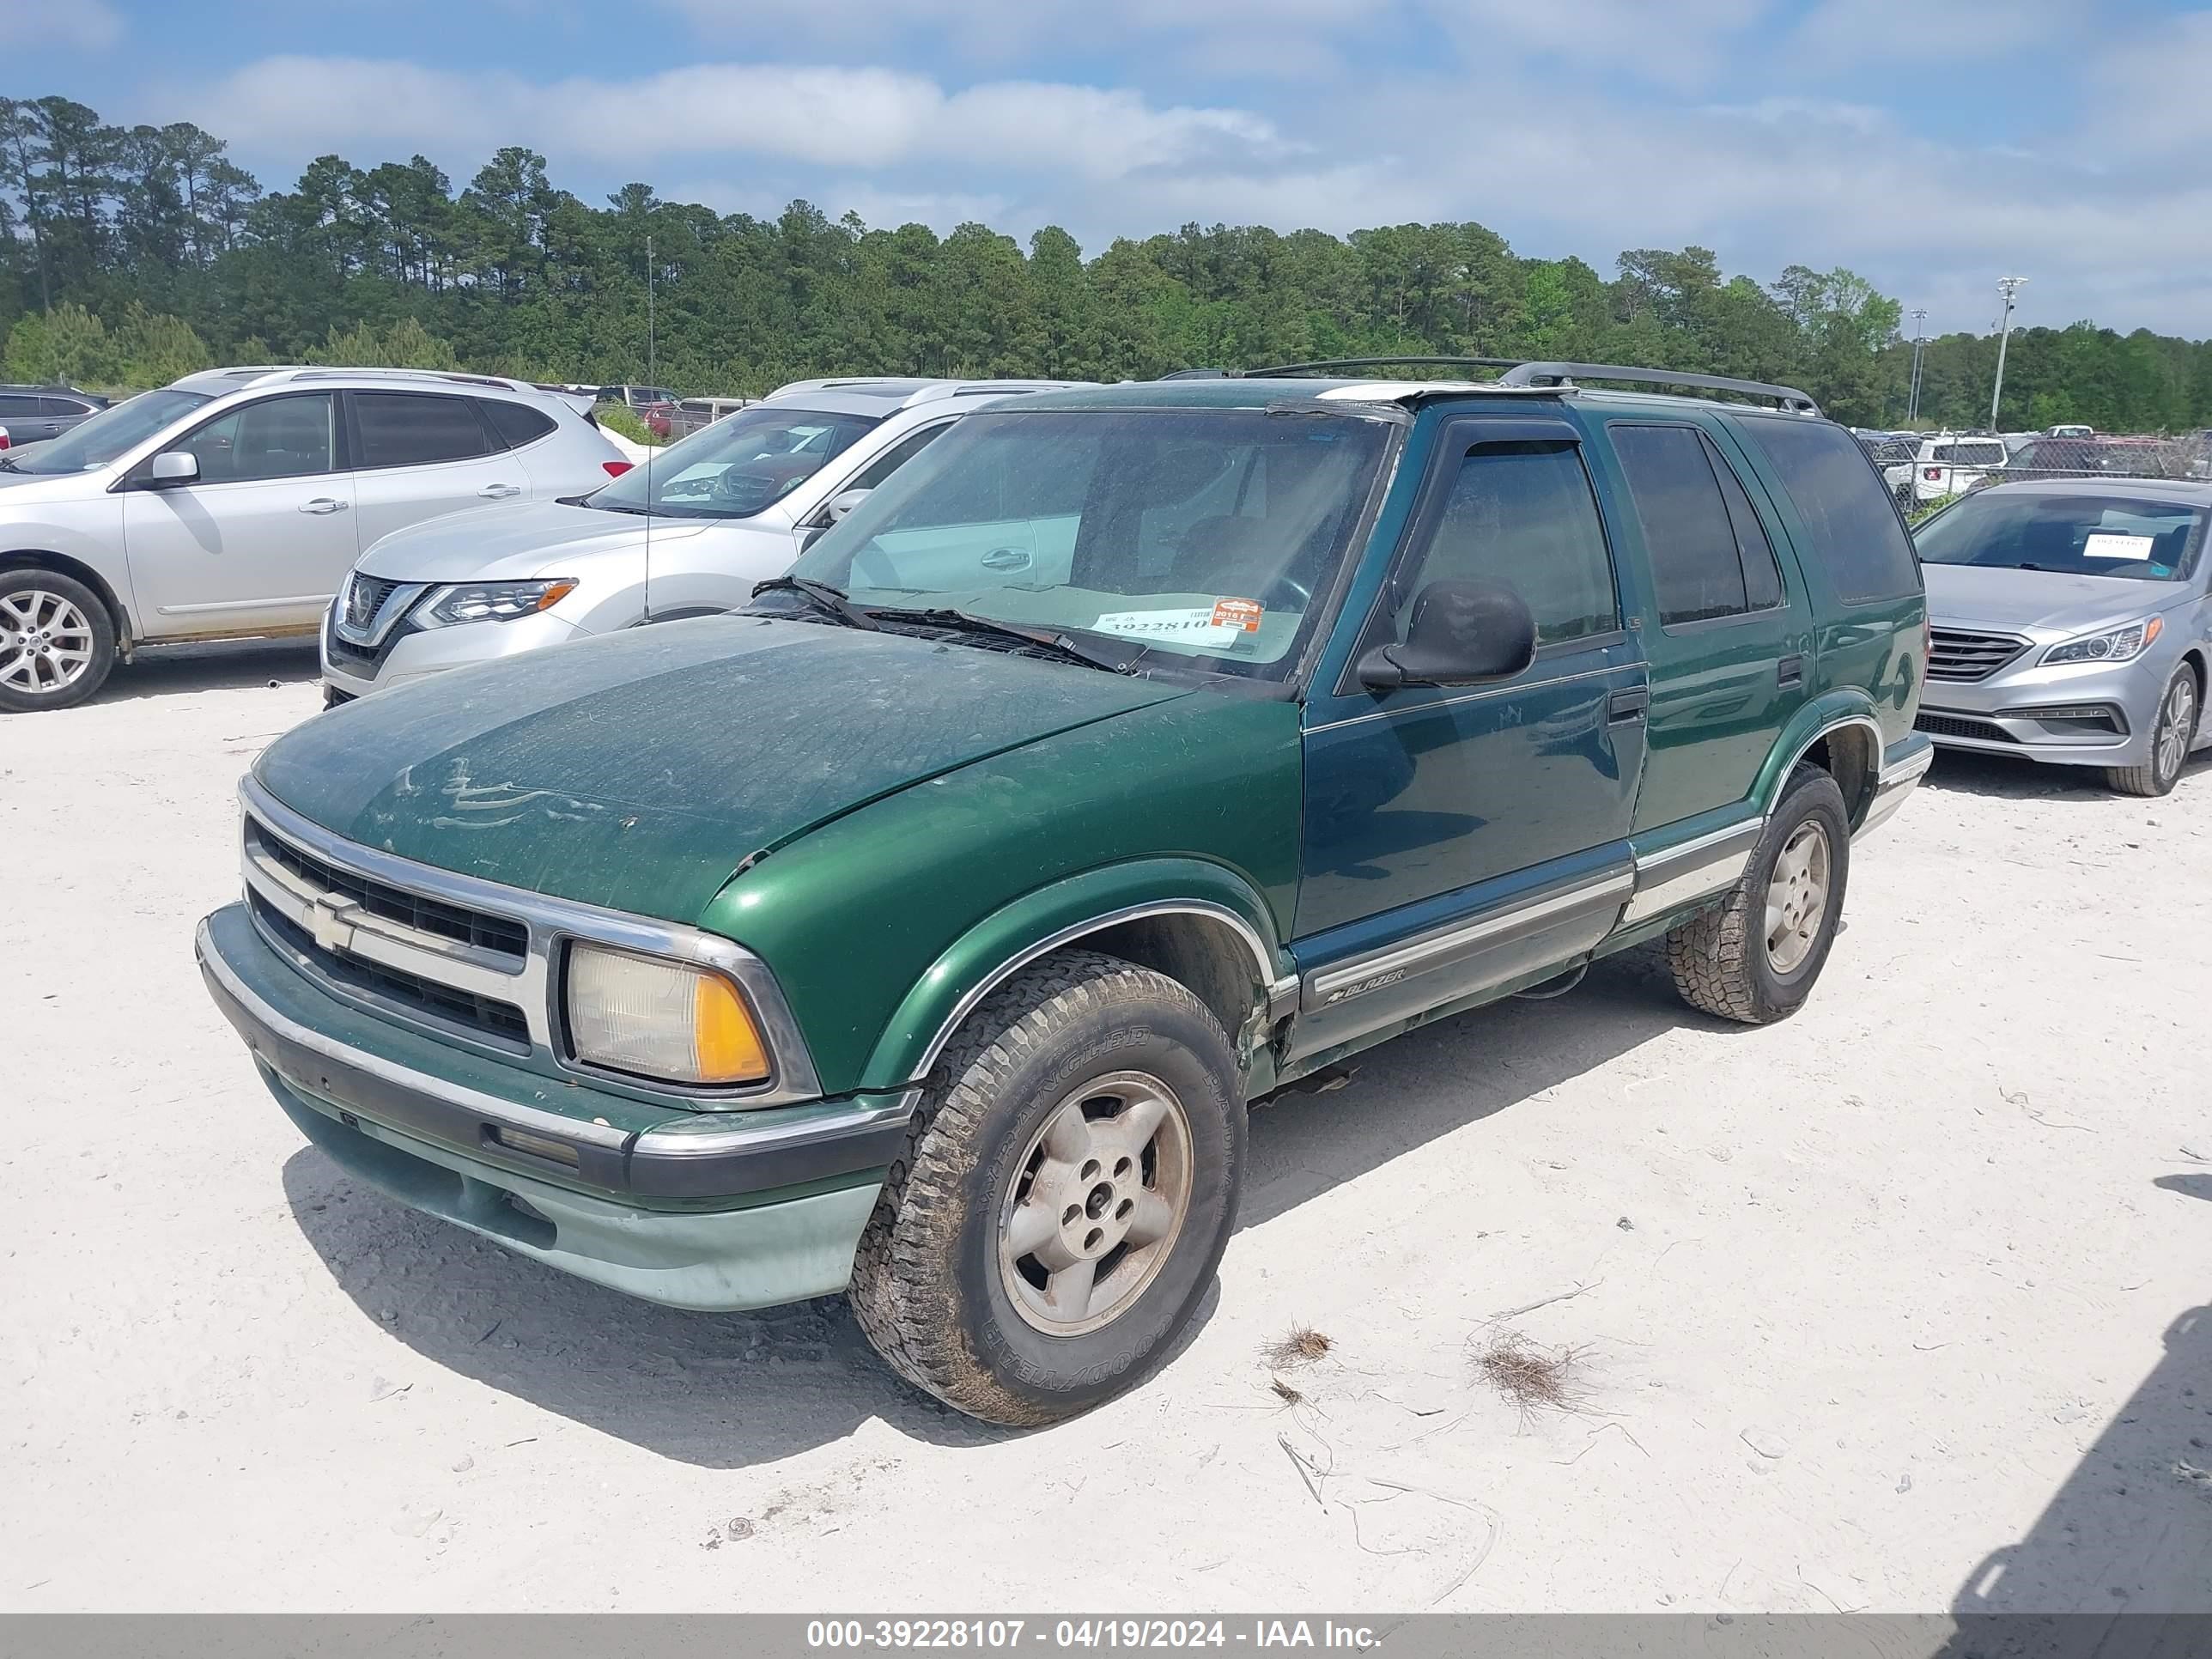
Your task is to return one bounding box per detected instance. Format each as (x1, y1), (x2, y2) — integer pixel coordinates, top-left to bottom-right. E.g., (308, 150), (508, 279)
(343, 392), (531, 550)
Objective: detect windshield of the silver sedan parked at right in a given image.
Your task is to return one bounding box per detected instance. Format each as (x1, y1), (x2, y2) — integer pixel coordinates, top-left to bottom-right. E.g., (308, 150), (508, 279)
(1913, 493), (2203, 581)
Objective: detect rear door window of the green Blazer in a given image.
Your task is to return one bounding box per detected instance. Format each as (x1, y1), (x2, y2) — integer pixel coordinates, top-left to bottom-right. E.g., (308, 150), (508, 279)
(1610, 422), (1778, 626)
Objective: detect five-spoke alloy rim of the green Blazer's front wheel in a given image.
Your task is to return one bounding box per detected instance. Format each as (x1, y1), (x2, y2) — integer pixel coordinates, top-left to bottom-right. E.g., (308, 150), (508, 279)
(998, 1071), (1192, 1336)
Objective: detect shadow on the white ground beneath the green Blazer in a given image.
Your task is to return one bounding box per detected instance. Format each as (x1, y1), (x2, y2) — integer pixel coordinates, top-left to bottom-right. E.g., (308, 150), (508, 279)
(283, 953), (1707, 1468)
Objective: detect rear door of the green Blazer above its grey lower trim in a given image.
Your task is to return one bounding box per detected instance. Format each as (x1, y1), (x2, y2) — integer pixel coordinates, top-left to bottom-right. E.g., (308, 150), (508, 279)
(1606, 416), (1814, 831)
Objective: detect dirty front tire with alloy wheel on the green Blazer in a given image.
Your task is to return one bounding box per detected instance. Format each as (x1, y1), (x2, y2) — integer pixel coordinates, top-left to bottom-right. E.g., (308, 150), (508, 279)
(852, 951), (1245, 1427)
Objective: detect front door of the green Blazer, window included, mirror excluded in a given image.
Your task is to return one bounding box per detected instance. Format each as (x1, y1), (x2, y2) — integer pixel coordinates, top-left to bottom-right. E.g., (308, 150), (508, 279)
(1291, 416), (1646, 1053)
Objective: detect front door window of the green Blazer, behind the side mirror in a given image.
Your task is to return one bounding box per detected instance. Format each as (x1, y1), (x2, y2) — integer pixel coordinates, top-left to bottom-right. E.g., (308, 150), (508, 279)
(1395, 442), (1620, 646)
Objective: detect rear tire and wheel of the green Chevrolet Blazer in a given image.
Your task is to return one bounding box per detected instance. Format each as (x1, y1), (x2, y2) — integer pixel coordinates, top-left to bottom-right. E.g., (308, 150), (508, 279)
(1666, 765), (1851, 1026)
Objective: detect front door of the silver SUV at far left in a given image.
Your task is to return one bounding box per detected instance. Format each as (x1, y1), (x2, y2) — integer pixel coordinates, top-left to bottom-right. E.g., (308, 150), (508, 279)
(122, 392), (361, 639)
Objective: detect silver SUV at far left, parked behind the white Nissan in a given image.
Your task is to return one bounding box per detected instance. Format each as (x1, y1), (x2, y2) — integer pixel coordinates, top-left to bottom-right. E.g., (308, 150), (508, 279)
(0, 368), (629, 712)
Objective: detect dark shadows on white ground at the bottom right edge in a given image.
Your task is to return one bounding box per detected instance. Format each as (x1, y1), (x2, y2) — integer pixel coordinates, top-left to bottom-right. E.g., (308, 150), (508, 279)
(1944, 1172), (2212, 1655)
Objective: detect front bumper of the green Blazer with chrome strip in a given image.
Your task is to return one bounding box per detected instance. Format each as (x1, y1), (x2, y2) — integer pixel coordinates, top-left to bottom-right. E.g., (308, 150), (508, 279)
(195, 905), (914, 1310)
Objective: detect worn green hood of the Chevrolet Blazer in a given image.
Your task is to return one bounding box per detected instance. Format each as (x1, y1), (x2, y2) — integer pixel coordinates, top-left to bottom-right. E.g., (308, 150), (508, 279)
(254, 615), (1190, 922)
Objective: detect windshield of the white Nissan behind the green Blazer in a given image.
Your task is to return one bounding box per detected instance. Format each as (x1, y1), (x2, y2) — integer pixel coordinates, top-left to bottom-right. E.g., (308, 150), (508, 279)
(591, 407), (878, 518)
